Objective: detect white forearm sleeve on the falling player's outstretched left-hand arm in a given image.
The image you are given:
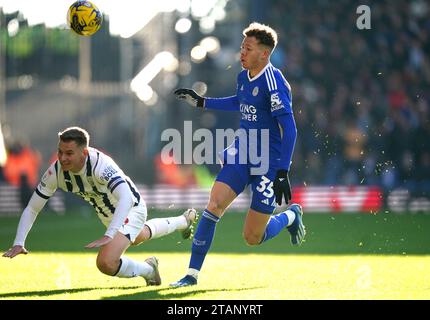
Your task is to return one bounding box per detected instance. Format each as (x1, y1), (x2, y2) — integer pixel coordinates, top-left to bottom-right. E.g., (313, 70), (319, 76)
(13, 192), (48, 246)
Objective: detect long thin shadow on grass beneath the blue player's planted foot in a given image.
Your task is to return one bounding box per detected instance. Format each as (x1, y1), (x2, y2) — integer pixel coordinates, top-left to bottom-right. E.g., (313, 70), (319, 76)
(102, 287), (263, 300)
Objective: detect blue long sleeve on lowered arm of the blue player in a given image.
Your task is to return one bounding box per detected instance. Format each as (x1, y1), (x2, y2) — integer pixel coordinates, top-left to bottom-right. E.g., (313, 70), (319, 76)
(276, 113), (297, 171)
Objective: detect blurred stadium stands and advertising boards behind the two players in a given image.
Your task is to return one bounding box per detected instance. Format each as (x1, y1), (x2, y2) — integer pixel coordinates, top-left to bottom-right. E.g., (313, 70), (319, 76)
(0, 0), (430, 242)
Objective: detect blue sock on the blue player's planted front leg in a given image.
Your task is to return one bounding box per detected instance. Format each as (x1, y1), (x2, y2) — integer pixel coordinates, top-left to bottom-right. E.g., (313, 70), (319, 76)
(189, 209), (219, 270)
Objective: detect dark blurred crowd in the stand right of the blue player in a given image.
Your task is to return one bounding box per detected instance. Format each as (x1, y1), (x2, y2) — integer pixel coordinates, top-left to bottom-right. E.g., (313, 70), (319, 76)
(256, 0), (430, 195)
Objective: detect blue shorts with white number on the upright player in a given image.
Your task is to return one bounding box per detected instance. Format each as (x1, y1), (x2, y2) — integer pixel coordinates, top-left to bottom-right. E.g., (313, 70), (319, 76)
(216, 164), (276, 214)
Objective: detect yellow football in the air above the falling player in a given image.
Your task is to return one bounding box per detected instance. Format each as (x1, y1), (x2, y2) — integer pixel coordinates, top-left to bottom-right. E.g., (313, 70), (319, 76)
(67, 1), (103, 36)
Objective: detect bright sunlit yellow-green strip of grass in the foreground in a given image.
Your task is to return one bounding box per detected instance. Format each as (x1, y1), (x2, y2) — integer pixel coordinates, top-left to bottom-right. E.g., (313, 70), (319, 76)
(0, 252), (430, 300)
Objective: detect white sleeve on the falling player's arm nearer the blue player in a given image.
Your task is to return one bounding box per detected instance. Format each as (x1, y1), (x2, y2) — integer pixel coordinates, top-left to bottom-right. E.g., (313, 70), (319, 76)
(105, 183), (134, 239)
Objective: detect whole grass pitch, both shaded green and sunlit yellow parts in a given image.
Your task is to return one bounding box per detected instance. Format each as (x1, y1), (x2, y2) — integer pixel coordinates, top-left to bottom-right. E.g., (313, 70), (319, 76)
(0, 212), (430, 300)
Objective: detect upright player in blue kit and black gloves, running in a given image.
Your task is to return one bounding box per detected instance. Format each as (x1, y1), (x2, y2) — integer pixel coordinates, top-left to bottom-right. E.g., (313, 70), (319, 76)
(171, 22), (305, 287)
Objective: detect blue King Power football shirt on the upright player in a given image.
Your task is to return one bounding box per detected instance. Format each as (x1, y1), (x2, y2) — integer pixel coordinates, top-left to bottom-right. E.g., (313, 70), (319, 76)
(205, 63), (295, 174)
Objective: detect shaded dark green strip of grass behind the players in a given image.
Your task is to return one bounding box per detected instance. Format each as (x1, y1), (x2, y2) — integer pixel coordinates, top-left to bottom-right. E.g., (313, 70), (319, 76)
(0, 211), (430, 255)
